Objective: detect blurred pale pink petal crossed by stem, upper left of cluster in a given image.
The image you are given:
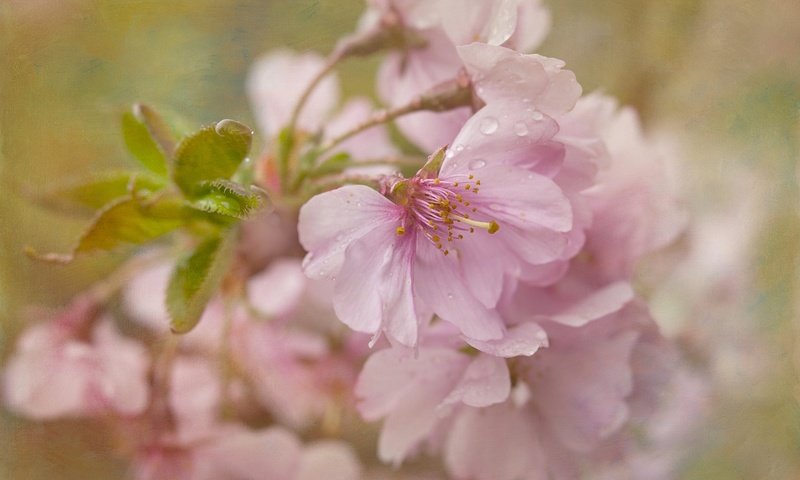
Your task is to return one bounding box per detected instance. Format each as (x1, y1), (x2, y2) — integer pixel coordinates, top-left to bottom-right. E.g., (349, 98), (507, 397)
(247, 50), (339, 137)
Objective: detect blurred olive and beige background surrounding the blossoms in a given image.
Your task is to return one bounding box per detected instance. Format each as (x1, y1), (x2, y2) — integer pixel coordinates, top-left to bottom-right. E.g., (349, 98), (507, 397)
(0, 0), (800, 480)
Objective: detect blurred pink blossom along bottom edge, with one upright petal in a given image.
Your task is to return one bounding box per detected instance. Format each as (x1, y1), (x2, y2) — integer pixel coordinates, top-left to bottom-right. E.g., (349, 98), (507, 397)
(133, 356), (361, 480)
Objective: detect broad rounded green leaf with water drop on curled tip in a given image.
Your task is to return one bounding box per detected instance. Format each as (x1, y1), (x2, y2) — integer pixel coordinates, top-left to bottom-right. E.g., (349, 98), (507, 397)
(172, 120), (253, 198)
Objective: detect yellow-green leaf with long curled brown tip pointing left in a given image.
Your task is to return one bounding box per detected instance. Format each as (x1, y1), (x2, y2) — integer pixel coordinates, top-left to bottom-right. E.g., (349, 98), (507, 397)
(26, 197), (184, 264)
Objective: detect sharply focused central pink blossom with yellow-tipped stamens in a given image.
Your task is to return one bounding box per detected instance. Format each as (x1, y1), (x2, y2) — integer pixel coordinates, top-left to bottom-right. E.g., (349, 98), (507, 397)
(298, 105), (572, 345)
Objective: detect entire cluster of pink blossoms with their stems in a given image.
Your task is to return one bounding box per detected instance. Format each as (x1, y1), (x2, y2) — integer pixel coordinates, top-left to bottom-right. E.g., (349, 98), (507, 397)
(3, 0), (684, 480)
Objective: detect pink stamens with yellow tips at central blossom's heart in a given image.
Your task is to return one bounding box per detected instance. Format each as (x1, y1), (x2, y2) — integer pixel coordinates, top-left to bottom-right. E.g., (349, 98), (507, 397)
(397, 174), (500, 255)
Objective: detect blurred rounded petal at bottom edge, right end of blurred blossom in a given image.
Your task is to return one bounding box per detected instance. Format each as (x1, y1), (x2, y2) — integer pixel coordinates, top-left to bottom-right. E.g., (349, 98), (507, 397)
(293, 440), (361, 480)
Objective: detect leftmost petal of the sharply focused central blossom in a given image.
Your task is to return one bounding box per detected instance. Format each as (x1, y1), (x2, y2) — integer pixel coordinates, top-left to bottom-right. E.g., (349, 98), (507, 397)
(297, 185), (402, 278)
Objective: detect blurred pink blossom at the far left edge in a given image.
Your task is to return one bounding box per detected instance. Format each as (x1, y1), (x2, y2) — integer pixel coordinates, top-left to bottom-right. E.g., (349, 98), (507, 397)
(3, 307), (149, 420)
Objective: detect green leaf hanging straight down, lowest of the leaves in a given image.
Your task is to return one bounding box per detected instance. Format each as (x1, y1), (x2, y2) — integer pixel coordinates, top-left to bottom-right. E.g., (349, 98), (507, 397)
(167, 234), (236, 333)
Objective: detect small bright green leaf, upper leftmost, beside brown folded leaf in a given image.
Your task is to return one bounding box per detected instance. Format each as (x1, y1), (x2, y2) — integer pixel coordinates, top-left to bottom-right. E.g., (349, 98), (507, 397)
(122, 105), (171, 176)
